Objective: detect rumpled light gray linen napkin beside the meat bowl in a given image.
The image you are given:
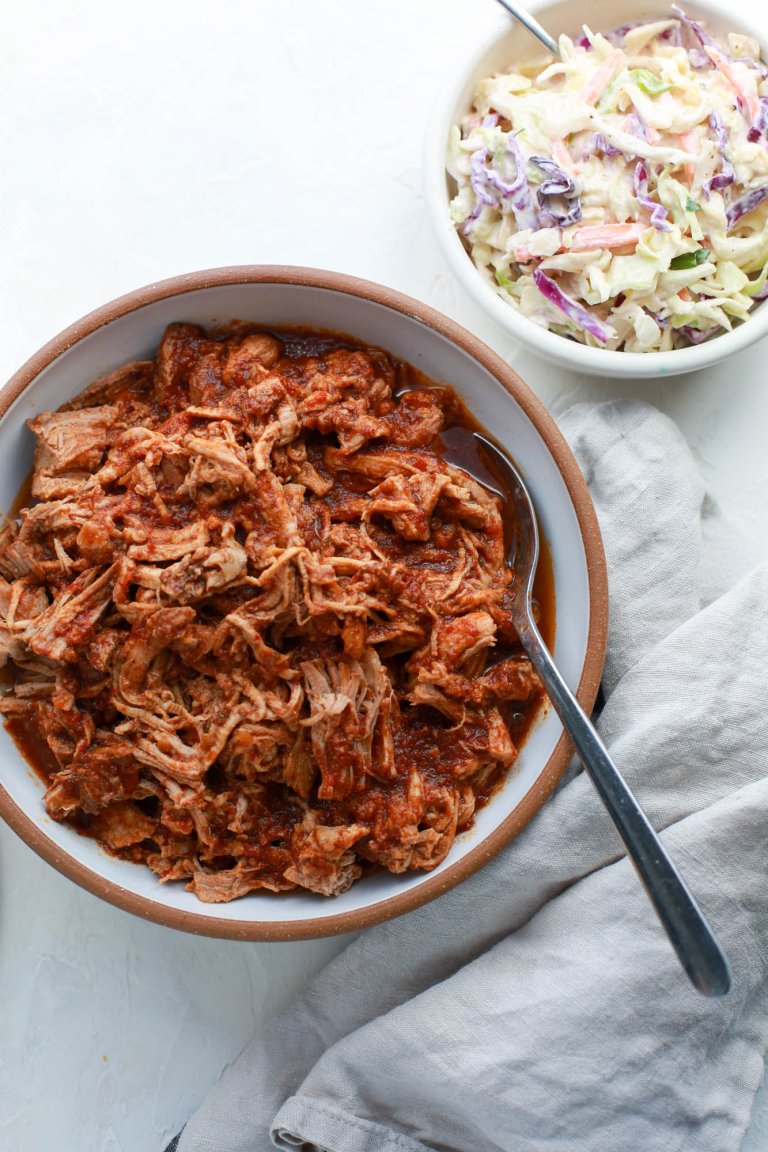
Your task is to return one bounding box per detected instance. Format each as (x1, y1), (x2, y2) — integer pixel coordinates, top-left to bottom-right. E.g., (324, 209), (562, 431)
(173, 403), (768, 1152)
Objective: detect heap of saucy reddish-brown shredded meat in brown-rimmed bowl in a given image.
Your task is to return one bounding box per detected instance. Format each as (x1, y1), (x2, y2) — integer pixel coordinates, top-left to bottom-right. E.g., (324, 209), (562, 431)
(0, 324), (540, 901)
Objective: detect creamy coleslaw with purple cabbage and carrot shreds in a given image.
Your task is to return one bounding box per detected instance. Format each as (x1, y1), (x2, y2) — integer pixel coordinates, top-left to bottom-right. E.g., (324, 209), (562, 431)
(447, 6), (768, 353)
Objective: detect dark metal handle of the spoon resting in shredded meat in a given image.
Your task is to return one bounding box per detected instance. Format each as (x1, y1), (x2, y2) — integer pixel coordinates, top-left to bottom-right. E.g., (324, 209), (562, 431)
(516, 611), (731, 996)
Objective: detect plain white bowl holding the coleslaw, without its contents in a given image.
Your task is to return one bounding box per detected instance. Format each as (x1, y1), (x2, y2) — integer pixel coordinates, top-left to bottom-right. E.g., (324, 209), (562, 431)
(423, 0), (768, 379)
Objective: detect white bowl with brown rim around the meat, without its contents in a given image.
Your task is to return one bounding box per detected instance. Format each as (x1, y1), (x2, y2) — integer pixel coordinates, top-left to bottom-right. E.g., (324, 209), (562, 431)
(0, 267), (606, 939)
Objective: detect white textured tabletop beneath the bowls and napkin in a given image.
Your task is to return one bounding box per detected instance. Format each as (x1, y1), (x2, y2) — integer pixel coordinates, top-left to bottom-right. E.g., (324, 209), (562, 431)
(0, 0), (768, 1152)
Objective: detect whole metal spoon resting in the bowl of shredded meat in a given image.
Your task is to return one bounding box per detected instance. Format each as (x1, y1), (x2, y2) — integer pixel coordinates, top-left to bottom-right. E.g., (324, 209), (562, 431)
(474, 432), (731, 996)
